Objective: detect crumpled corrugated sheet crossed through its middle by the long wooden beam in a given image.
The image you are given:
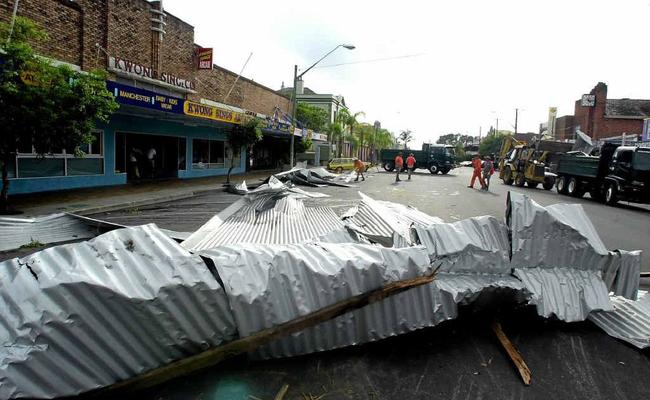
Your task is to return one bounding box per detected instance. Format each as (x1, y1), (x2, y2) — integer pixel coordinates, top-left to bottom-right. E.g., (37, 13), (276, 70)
(201, 243), (445, 357)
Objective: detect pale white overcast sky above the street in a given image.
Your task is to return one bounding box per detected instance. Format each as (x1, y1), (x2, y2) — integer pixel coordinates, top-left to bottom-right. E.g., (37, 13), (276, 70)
(164, 0), (650, 146)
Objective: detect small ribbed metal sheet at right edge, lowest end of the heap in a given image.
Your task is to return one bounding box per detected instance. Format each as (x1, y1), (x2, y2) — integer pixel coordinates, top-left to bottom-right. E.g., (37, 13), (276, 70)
(589, 292), (650, 349)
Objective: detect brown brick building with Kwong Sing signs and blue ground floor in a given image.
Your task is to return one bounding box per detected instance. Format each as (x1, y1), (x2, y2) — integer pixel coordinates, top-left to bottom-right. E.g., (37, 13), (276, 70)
(0, 0), (290, 194)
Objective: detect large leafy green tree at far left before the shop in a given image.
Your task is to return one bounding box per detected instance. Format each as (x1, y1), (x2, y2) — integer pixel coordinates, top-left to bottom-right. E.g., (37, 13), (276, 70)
(0, 17), (118, 211)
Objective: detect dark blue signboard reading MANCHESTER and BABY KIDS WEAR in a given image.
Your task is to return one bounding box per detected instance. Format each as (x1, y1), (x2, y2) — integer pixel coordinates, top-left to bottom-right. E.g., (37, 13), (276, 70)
(106, 81), (185, 114)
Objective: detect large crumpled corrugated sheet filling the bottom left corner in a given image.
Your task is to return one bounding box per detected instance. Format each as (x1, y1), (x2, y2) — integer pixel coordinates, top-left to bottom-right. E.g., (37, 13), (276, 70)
(0, 225), (236, 398)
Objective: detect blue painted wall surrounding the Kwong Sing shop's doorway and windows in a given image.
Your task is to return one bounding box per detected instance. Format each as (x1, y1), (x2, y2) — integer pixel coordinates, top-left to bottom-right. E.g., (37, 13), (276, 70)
(9, 114), (246, 195)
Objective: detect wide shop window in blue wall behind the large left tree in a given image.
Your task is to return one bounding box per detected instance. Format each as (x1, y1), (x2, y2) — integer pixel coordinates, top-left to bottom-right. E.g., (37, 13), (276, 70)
(14, 131), (104, 178)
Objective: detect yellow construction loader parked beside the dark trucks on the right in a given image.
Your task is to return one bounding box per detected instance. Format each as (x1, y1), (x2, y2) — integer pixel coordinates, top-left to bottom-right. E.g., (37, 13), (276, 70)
(499, 136), (556, 190)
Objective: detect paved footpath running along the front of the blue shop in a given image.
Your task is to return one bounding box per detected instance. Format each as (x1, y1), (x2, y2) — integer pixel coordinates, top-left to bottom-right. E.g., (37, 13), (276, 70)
(9, 170), (279, 218)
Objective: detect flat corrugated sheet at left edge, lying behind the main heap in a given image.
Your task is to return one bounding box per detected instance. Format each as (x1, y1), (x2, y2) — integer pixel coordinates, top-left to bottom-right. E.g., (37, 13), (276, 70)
(0, 213), (120, 251)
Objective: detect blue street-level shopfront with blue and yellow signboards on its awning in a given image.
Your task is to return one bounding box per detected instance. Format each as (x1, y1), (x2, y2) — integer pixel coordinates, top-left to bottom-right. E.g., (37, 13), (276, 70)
(9, 82), (245, 194)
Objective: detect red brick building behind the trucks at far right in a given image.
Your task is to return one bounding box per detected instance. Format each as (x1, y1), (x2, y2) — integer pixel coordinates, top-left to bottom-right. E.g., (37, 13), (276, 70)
(573, 82), (650, 139)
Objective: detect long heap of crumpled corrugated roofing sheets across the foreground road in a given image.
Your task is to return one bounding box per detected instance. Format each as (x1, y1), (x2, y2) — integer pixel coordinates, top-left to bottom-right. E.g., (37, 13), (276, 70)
(0, 184), (650, 398)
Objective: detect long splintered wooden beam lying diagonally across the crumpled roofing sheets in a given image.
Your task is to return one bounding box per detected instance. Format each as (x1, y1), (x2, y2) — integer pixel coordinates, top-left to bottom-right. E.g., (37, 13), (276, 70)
(94, 269), (437, 395)
